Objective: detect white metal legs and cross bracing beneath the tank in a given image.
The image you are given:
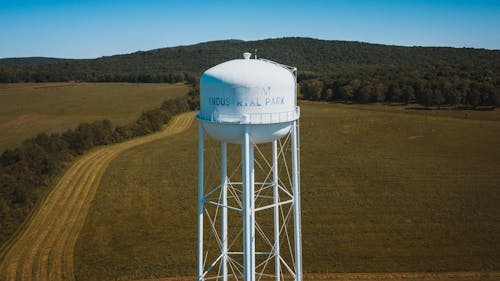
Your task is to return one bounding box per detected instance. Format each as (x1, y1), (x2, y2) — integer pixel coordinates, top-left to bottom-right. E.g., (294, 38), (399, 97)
(198, 122), (302, 281)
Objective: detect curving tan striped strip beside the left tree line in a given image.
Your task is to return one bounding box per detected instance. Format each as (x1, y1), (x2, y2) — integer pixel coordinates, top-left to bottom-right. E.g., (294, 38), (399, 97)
(0, 112), (194, 281)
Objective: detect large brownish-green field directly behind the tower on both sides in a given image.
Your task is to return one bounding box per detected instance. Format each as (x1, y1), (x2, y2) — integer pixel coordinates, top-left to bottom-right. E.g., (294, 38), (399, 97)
(74, 103), (500, 280)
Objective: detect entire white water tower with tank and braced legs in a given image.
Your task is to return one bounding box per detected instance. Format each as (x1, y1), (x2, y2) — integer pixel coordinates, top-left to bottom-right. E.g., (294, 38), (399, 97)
(197, 53), (302, 281)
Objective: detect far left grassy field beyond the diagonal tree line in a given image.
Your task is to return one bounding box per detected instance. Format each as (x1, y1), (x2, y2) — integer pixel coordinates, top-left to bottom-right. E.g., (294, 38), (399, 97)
(0, 83), (188, 152)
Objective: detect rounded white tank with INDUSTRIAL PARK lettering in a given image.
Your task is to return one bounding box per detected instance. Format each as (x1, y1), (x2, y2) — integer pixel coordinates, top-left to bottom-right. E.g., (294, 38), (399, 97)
(198, 53), (299, 143)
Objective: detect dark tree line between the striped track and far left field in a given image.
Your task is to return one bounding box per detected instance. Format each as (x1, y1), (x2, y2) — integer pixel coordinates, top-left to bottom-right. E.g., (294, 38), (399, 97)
(0, 88), (197, 245)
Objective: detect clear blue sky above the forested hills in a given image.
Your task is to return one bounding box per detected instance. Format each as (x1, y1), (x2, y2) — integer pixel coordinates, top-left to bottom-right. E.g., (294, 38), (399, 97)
(0, 0), (500, 58)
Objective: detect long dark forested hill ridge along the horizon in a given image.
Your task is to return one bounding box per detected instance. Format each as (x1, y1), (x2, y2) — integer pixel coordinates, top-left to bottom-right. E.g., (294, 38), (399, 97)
(0, 38), (500, 82)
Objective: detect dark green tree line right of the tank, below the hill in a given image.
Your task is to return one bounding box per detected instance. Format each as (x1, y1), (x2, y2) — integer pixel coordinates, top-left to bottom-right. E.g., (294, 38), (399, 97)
(299, 67), (500, 108)
